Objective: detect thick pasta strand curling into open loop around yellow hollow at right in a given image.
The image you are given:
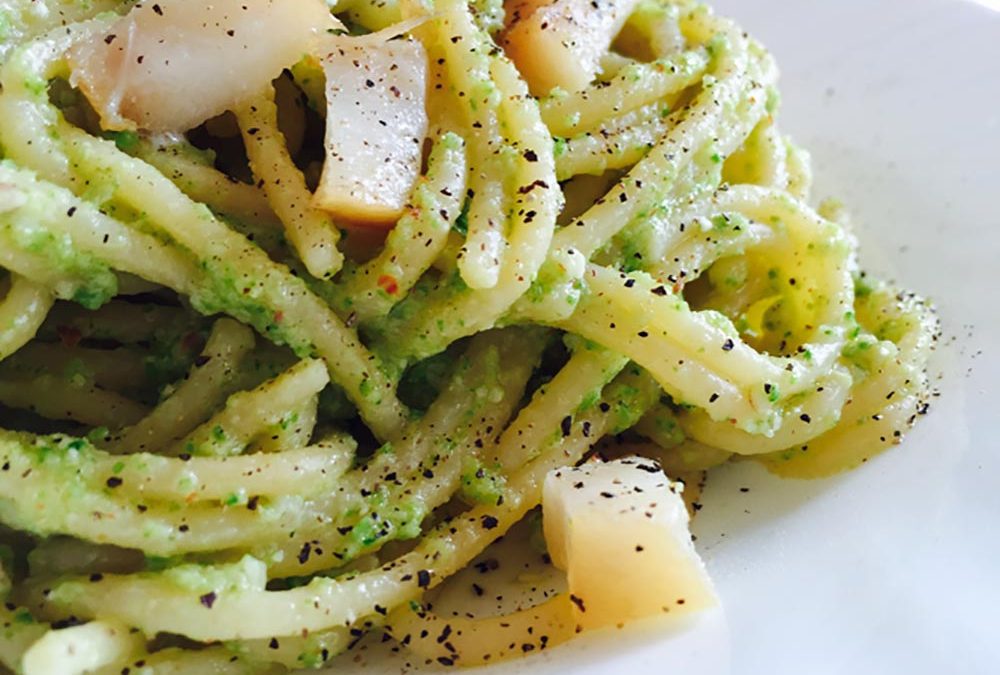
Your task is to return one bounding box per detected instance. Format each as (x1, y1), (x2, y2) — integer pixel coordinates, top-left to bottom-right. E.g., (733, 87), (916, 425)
(564, 188), (853, 435)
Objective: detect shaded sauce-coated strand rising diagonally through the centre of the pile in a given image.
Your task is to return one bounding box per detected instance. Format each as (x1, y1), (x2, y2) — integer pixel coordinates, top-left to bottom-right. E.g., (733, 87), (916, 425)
(250, 330), (545, 575)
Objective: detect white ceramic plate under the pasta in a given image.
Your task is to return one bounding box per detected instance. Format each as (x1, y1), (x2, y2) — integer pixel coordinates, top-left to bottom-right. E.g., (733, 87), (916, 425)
(338, 0), (1000, 675)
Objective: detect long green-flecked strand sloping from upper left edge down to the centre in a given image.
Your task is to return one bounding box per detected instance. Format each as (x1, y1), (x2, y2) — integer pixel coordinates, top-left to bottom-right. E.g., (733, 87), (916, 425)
(0, 21), (404, 437)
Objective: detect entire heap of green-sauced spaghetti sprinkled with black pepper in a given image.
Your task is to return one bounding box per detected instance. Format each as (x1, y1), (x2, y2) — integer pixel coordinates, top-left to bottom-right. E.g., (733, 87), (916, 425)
(0, 0), (937, 674)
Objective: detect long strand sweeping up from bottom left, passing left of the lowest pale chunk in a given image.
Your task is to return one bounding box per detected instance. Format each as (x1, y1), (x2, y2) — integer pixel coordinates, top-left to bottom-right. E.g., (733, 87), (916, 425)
(33, 374), (655, 640)
